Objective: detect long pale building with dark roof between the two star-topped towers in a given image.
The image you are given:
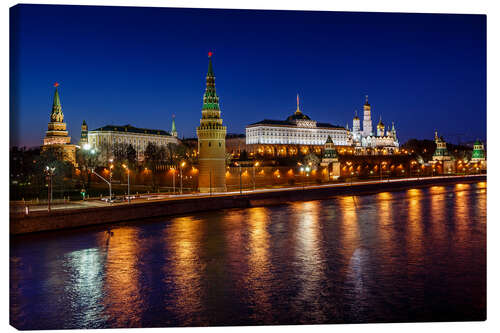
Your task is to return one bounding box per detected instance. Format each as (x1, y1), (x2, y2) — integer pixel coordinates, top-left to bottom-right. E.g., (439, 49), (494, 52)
(86, 125), (180, 161)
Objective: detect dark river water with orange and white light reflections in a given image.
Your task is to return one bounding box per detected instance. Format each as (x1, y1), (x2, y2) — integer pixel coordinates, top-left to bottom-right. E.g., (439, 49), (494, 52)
(10, 182), (486, 329)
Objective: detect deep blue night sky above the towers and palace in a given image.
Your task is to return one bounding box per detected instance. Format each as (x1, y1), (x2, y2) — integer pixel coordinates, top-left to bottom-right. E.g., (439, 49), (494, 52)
(10, 5), (486, 146)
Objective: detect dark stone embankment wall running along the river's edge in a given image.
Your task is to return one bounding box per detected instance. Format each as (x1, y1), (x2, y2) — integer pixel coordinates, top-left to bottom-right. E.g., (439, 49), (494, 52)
(10, 175), (486, 235)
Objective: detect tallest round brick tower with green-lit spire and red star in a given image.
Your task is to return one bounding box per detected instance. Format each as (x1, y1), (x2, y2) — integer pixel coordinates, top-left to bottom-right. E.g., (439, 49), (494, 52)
(196, 52), (226, 193)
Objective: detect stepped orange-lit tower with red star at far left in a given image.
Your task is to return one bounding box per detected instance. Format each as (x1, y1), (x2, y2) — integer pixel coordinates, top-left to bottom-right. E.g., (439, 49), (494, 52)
(41, 82), (76, 165)
